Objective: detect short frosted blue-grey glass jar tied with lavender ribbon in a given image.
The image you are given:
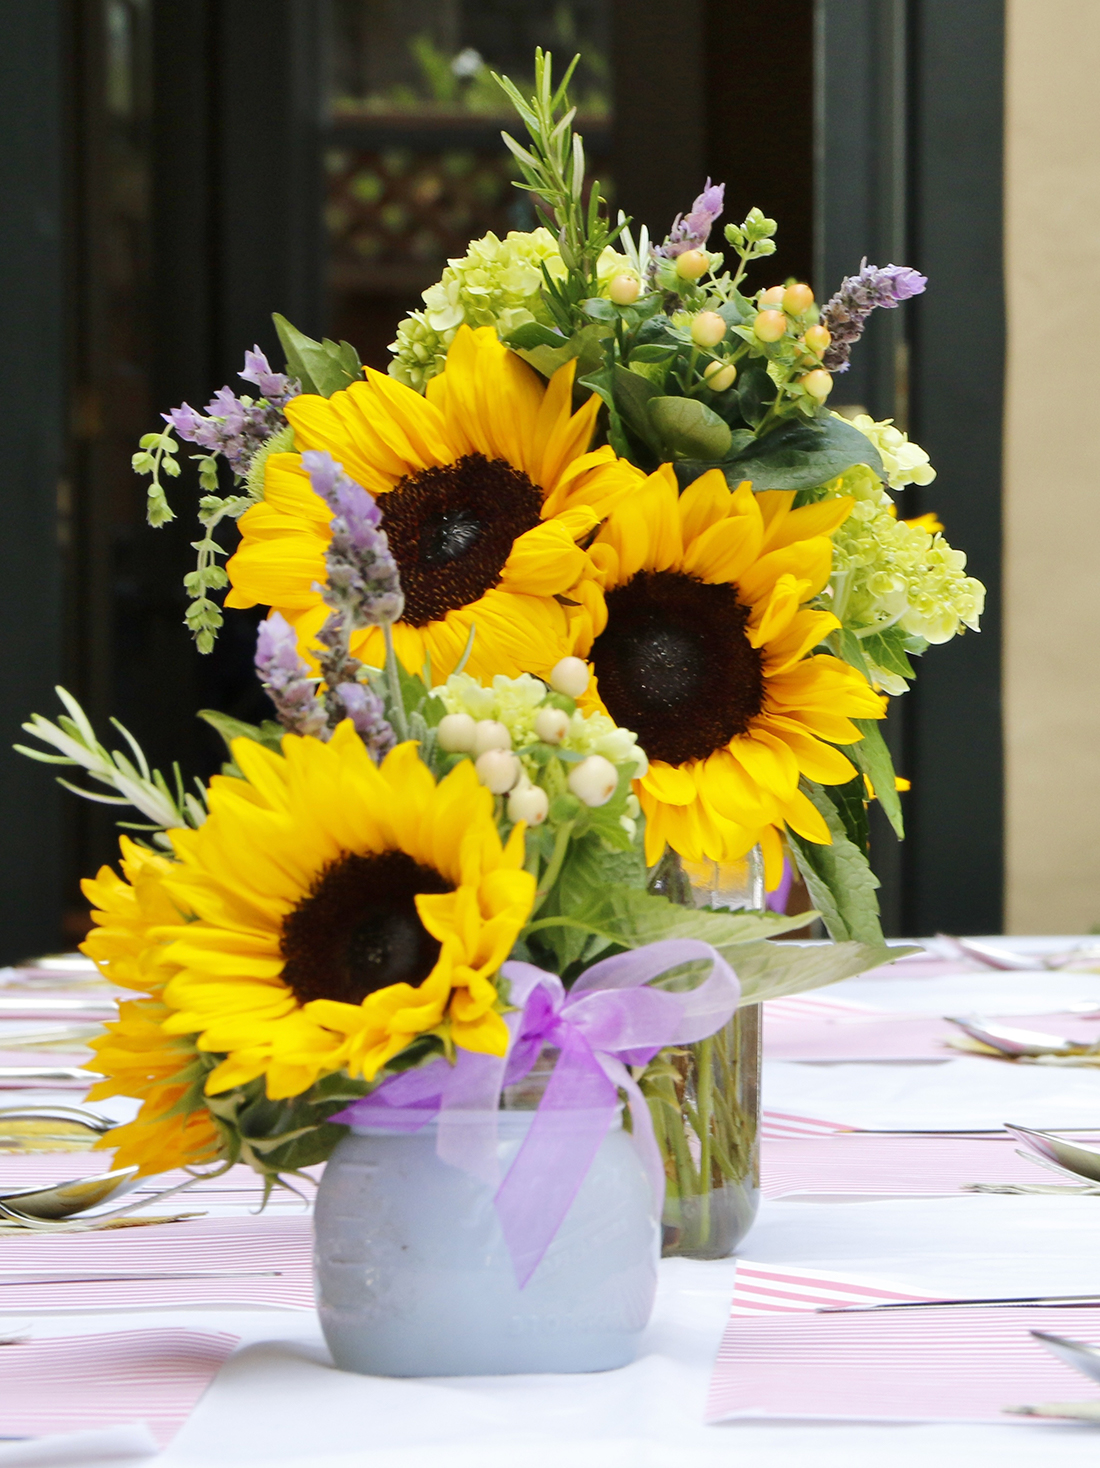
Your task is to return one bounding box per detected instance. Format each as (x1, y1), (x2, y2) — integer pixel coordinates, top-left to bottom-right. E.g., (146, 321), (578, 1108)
(314, 1111), (661, 1377)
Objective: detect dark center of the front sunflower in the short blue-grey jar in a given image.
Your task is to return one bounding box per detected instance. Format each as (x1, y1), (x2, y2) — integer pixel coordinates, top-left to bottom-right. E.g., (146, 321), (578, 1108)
(279, 851), (454, 1004)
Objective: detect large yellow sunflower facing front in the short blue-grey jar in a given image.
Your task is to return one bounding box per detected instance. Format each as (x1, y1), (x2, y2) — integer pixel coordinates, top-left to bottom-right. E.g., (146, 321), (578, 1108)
(157, 721), (535, 1100)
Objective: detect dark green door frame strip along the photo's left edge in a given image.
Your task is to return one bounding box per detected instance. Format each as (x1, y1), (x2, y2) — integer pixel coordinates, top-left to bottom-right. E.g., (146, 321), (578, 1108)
(0, 0), (68, 963)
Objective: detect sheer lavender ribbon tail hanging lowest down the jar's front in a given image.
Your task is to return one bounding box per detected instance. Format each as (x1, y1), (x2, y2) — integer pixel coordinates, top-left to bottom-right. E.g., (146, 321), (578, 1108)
(495, 1026), (618, 1289)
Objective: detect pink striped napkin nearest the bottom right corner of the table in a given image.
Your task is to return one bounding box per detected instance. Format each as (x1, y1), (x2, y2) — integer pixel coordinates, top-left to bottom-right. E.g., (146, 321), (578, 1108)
(706, 1309), (1100, 1421)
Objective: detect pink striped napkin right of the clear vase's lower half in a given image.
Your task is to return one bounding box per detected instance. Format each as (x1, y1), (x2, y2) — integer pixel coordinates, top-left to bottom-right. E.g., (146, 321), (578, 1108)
(761, 1132), (1084, 1198)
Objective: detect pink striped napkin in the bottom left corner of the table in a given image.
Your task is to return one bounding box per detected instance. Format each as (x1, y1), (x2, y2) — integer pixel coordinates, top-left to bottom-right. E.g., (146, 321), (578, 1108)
(0, 1330), (238, 1447)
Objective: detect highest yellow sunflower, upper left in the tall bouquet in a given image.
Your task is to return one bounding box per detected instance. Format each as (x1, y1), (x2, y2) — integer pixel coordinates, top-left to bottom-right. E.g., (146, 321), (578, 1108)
(226, 326), (642, 678)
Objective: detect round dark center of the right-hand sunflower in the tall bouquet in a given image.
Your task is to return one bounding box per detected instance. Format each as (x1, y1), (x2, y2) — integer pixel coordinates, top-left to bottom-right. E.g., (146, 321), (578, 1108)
(592, 571), (764, 765)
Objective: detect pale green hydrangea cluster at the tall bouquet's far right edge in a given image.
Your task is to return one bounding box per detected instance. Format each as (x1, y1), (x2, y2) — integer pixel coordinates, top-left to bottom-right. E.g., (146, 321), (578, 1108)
(827, 464), (985, 693)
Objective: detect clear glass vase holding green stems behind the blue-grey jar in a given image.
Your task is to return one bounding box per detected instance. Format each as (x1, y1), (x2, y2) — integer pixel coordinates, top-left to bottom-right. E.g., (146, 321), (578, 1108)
(639, 850), (765, 1260)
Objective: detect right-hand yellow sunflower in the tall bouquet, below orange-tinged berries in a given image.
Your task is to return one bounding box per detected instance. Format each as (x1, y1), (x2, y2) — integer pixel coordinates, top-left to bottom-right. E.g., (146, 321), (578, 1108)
(579, 465), (886, 885)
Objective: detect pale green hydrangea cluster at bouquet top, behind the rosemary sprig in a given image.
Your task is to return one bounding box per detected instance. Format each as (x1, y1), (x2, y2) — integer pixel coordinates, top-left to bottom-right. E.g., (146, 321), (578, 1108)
(389, 228), (630, 392)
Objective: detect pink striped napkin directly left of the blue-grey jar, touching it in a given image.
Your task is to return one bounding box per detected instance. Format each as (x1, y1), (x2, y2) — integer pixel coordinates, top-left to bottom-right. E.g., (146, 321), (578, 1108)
(0, 1215), (313, 1314)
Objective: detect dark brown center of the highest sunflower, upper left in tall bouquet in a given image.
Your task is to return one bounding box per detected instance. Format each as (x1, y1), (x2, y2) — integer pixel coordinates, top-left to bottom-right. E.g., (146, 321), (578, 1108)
(382, 454), (542, 627)
